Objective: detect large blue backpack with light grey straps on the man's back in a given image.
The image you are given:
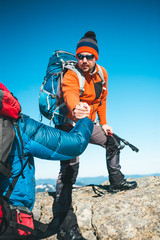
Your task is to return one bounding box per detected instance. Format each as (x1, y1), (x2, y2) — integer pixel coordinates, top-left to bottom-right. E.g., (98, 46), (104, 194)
(39, 50), (105, 125)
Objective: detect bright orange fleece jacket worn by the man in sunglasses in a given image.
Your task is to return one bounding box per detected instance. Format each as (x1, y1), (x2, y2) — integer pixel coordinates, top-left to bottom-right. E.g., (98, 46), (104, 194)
(62, 63), (108, 125)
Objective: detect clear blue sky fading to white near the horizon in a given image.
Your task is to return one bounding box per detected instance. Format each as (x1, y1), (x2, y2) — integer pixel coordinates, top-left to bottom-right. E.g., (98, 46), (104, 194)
(0, 0), (160, 178)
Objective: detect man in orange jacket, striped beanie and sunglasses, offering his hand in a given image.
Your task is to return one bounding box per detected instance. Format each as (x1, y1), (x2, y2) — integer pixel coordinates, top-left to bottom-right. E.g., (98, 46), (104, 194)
(55, 31), (137, 240)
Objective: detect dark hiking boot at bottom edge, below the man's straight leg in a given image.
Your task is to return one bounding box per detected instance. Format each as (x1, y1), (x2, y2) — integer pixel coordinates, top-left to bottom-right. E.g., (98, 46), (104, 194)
(57, 225), (87, 240)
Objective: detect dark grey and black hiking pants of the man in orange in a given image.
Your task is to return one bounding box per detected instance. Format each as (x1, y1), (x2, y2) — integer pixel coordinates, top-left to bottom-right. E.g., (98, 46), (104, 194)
(54, 125), (124, 230)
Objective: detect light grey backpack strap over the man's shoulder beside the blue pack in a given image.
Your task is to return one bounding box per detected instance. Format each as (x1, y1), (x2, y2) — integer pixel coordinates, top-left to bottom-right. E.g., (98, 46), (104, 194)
(65, 65), (85, 96)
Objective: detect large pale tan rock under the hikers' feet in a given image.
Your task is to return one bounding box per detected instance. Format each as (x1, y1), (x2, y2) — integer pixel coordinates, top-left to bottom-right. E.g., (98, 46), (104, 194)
(33, 176), (160, 240)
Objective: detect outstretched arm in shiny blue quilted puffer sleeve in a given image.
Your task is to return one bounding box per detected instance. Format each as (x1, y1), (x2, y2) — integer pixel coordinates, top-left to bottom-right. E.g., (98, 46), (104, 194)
(20, 116), (93, 160)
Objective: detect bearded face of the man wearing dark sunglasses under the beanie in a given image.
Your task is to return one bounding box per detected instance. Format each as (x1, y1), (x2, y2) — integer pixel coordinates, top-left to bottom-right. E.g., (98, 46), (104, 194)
(77, 52), (96, 73)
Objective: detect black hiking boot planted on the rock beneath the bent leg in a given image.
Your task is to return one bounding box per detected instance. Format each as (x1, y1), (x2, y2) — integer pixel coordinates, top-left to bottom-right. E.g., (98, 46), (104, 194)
(108, 180), (137, 193)
